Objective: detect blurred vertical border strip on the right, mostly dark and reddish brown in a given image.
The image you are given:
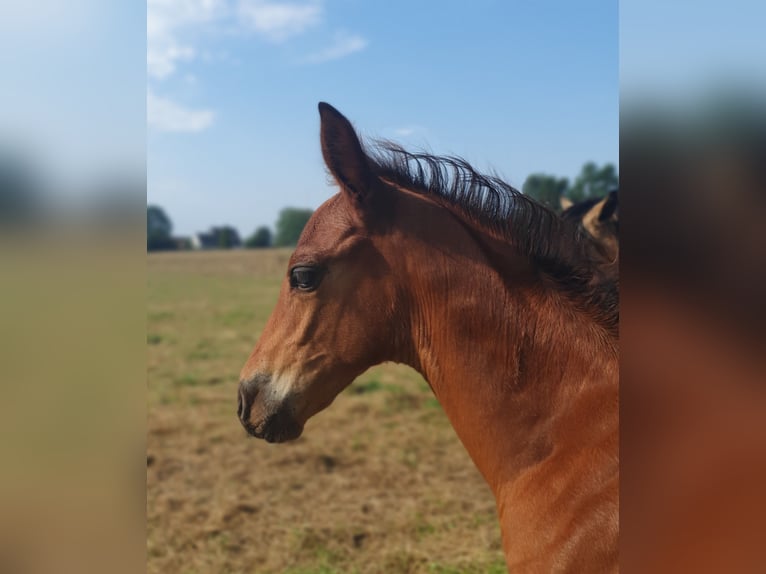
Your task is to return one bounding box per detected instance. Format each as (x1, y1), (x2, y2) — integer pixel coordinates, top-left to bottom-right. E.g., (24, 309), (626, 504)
(620, 1), (766, 572)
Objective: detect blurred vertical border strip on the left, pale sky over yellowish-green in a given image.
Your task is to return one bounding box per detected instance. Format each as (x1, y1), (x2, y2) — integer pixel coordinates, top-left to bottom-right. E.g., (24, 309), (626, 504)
(0, 0), (146, 572)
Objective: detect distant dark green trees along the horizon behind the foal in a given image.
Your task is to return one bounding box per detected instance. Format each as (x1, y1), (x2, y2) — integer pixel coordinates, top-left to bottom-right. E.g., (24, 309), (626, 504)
(146, 162), (619, 251)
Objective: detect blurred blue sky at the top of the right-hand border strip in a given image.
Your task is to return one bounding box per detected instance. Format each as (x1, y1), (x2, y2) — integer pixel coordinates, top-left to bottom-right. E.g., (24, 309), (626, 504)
(619, 0), (766, 102)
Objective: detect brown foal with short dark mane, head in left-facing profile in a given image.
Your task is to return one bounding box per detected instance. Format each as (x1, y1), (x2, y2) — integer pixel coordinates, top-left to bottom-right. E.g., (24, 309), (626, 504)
(238, 103), (618, 572)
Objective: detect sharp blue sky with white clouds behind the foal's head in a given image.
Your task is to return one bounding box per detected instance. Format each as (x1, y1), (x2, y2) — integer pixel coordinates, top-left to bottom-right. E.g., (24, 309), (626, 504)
(147, 0), (619, 235)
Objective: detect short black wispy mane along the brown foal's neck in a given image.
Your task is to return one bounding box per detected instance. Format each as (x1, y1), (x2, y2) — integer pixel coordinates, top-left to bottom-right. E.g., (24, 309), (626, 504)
(368, 140), (618, 332)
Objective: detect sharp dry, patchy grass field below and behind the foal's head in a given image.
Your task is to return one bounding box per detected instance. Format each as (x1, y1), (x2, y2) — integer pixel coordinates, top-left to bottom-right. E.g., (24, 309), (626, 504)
(146, 250), (506, 574)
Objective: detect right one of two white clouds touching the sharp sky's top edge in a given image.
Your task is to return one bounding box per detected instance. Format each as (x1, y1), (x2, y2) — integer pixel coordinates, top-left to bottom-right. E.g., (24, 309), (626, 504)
(239, 0), (322, 42)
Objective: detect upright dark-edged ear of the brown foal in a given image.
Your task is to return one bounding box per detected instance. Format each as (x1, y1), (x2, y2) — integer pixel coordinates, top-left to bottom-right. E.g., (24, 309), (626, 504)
(319, 102), (374, 207)
